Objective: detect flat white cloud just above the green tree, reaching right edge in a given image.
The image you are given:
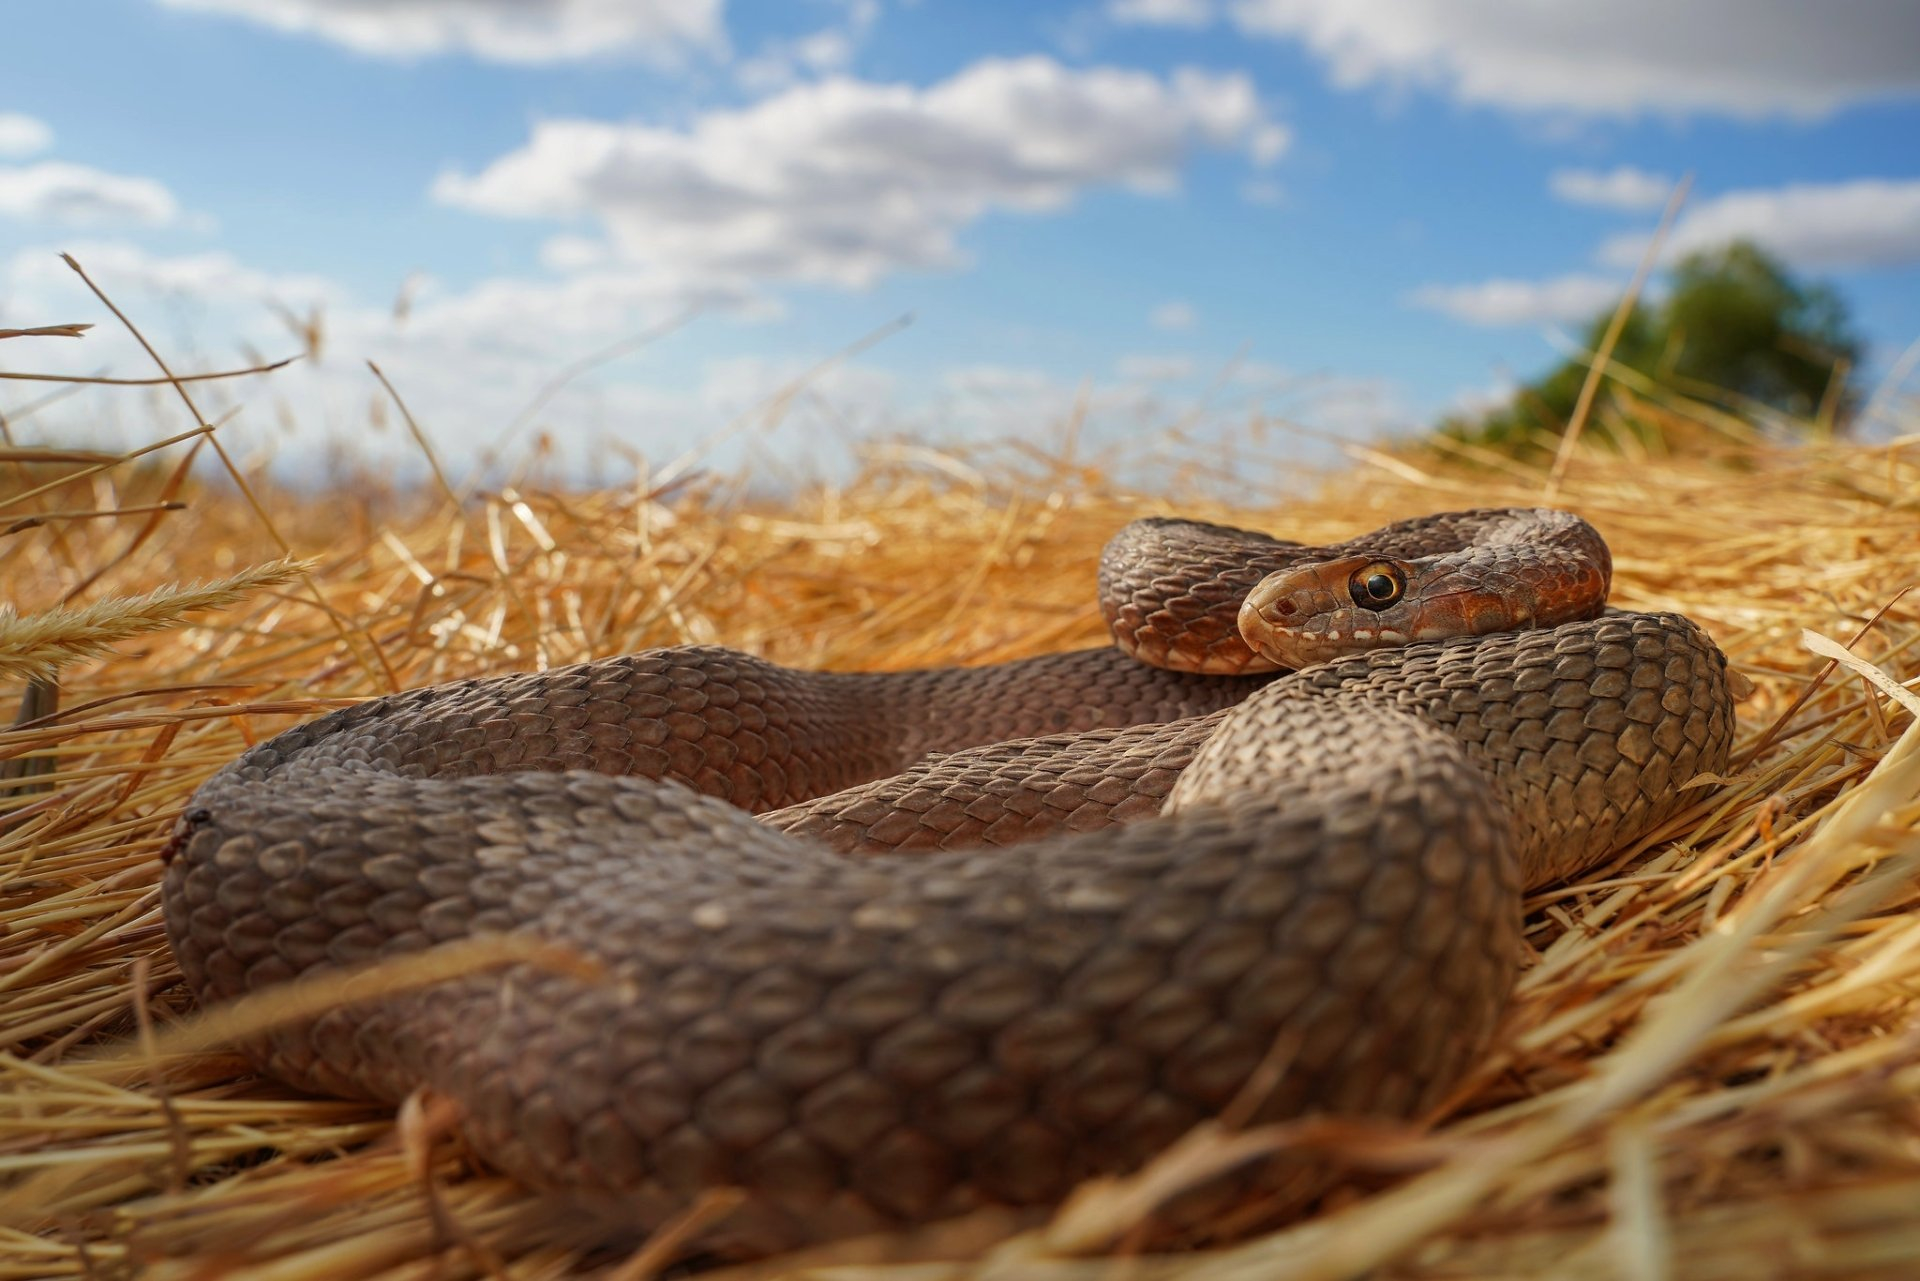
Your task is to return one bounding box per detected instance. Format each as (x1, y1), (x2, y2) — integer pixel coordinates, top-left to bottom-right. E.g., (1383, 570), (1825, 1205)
(1599, 179), (1920, 269)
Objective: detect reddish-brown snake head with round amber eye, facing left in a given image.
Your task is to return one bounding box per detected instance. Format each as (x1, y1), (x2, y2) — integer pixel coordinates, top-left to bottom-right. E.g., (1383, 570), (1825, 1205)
(1240, 555), (1542, 668)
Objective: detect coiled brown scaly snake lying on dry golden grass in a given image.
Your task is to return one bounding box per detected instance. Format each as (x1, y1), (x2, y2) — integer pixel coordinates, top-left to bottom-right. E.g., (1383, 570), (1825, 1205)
(163, 509), (1734, 1252)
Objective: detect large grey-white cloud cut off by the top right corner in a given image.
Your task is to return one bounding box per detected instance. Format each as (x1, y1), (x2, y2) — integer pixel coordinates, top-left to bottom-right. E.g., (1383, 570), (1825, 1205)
(1231, 0), (1920, 117)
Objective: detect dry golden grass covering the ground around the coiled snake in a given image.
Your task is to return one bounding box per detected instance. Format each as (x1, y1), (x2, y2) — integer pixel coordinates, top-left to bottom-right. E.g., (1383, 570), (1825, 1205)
(0, 338), (1920, 1281)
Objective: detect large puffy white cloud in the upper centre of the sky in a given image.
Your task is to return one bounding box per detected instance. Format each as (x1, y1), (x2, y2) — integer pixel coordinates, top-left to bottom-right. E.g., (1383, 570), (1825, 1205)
(434, 58), (1284, 288)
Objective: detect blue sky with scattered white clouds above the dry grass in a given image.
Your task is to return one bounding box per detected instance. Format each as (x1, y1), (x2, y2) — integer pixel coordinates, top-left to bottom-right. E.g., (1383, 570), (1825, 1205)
(0, 0), (1920, 476)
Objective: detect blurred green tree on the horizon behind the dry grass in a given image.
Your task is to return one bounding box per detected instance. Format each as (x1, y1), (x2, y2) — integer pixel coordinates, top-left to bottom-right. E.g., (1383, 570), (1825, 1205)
(1440, 240), (1860, 451)
